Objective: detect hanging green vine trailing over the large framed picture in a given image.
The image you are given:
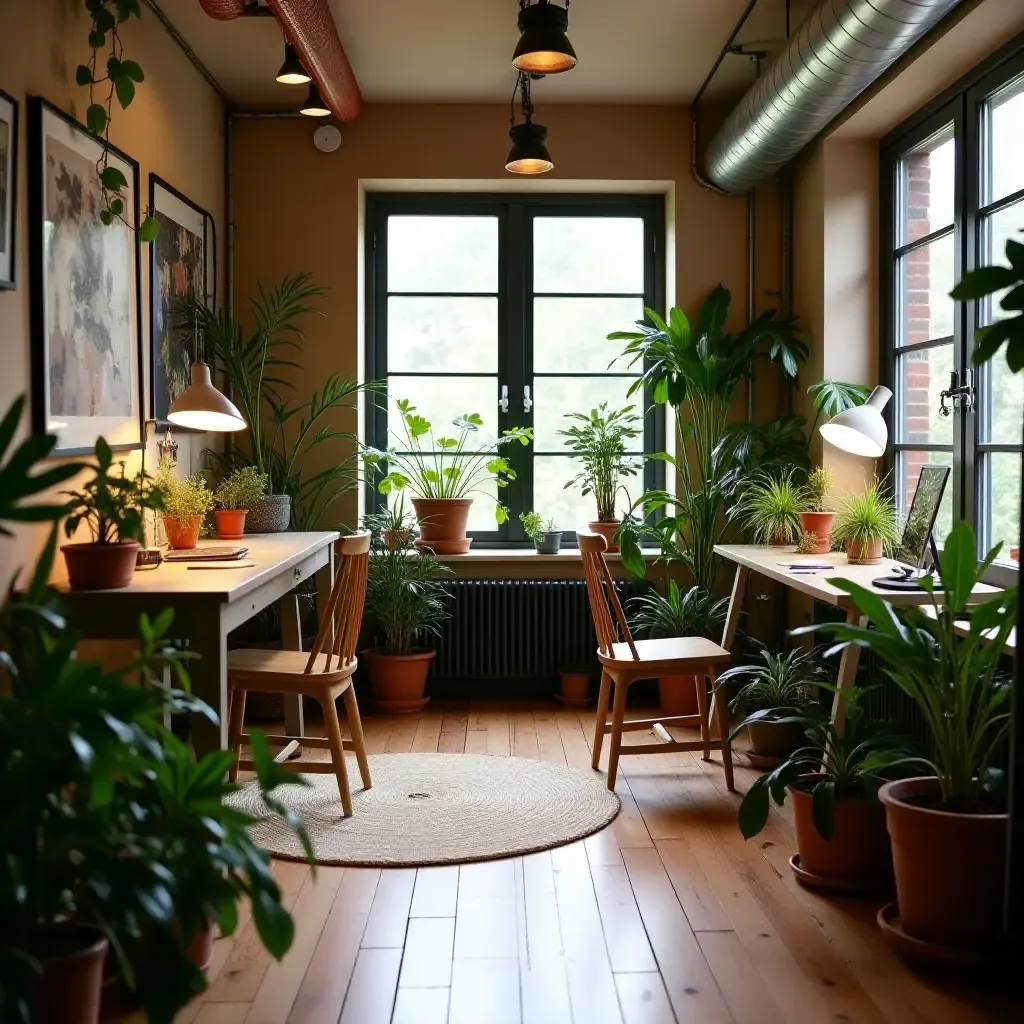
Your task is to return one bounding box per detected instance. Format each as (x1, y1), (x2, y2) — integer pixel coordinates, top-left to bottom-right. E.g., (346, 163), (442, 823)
(75, 0), (158, 242)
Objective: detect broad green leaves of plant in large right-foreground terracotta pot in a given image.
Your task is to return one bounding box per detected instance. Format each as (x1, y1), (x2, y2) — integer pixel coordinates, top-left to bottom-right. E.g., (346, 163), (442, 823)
(796, 522), (1018, 813)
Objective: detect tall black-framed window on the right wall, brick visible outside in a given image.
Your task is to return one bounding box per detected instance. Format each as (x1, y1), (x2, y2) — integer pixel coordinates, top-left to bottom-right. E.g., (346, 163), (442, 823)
(882, 41), (1024, 559)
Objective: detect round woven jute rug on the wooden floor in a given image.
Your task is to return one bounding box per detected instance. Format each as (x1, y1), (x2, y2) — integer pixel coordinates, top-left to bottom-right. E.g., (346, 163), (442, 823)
(228, 754), (618, 867)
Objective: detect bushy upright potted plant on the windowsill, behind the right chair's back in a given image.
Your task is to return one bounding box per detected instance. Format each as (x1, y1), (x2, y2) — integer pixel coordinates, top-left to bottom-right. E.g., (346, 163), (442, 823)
(558, 401), (643, 551)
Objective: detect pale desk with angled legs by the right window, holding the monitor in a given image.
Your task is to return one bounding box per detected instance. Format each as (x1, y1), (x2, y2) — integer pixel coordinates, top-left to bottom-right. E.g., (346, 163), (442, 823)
(715, 544), (998, 726)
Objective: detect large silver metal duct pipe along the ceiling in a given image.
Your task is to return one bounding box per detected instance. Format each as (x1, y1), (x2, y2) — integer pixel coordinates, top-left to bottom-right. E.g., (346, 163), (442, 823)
(708, 0), (959, 193)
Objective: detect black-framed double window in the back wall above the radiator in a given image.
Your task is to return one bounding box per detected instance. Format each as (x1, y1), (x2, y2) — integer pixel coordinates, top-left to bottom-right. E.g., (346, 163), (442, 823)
(367, 196), (665, 544)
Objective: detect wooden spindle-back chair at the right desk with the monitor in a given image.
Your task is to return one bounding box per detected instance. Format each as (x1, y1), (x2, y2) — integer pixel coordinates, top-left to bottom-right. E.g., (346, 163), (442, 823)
(577, 532), (734, 790)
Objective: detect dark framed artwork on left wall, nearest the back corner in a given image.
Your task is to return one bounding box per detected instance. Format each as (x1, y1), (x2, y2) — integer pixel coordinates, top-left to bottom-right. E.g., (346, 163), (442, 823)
(150, 174), (213, 421)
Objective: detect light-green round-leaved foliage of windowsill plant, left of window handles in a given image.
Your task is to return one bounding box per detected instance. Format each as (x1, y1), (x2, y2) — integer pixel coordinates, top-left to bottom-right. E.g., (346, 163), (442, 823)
(362, 398), (534, 523)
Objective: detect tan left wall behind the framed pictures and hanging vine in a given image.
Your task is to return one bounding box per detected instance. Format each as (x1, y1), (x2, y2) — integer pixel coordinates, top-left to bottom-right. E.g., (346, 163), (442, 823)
(0, 0), (224, 580)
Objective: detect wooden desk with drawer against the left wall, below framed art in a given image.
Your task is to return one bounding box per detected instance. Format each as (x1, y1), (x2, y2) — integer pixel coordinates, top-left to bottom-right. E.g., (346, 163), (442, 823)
(65, 530), (339, 755)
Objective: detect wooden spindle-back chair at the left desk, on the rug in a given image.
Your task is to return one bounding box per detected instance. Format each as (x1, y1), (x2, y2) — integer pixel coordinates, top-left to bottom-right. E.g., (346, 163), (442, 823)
(227, 532), (372, 818)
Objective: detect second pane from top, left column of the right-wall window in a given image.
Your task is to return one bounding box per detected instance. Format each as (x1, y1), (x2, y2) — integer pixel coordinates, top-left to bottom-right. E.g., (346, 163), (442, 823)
(897, 233), (954, 346)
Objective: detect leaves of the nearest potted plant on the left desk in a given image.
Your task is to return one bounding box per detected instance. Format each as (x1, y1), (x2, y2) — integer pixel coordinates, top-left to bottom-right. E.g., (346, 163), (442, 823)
(58, 437), (167, 544)
